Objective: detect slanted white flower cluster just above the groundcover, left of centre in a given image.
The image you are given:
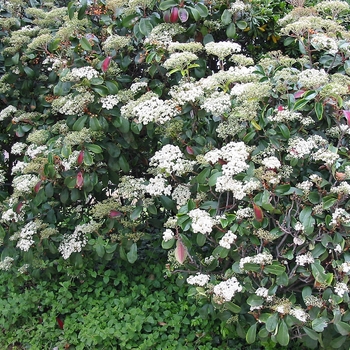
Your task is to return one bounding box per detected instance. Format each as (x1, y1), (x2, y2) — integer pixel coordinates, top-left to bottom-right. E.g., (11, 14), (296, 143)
(58, 221), (101, 259)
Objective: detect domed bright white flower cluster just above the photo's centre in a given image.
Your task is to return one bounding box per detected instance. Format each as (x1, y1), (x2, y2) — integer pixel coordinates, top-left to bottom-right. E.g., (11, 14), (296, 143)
(150, 145), (195, 176)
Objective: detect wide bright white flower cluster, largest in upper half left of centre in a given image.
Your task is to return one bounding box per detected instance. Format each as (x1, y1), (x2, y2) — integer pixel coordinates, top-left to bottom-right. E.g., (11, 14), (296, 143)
(132, 96), (178, 125)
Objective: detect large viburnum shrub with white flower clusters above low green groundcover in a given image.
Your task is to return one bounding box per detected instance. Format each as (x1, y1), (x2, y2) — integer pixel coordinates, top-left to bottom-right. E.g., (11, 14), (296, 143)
(0, 0), (350, 349)
